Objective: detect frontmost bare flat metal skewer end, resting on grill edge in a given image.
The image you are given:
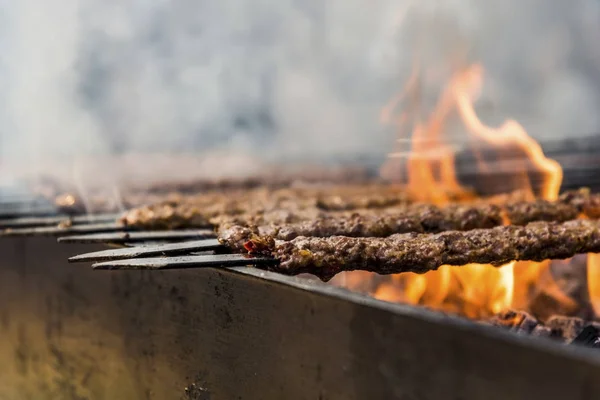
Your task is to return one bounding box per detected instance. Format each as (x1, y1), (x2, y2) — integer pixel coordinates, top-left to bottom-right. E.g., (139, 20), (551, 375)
(93, 254), (279, 270)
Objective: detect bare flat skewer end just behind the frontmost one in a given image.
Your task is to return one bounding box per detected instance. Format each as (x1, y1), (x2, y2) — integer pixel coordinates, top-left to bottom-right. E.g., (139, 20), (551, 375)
(69, 239), (226, 262)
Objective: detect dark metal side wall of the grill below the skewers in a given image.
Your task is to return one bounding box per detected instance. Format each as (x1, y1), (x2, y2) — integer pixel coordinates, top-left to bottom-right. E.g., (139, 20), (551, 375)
(0, 237), (600, 400)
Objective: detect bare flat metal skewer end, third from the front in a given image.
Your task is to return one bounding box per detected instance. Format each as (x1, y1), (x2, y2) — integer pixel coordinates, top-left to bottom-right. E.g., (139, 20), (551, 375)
(58, 229), (215, 244)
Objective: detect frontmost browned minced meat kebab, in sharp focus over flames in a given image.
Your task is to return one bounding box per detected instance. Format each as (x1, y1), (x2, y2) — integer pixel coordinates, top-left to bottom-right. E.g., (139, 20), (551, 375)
(227, 220), (600, 281)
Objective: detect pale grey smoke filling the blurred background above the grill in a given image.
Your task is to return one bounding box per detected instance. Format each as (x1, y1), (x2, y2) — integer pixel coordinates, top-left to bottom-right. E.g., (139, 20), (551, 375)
(0, 0), (600, 183)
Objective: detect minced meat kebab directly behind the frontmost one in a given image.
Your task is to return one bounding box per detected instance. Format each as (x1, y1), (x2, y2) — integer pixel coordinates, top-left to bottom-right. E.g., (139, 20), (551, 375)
(215, 191), (600, 251)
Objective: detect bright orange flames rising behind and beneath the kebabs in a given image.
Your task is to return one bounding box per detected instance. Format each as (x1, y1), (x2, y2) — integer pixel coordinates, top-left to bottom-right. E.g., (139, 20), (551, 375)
(362, 64), (576, 318)
